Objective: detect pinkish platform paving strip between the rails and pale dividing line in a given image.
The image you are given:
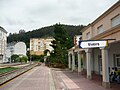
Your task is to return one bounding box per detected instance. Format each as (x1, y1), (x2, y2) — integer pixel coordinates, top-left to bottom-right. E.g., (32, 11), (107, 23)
(0, 65), (55, 90)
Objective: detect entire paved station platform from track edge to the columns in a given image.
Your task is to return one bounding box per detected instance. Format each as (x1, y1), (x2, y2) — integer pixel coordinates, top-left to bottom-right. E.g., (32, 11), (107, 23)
(0, 65), (120, 90)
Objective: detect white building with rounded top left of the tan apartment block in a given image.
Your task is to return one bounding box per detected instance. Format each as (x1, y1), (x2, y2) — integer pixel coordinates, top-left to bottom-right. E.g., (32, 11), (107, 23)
(6, 42), (27, 62)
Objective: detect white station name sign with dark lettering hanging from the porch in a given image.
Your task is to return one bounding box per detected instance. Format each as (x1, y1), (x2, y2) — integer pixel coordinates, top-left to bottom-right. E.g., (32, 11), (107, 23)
(79, 40), (108, 48)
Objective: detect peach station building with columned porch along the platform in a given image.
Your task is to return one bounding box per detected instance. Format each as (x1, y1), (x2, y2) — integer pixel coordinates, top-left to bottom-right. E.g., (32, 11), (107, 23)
(69, 1), (120, 87)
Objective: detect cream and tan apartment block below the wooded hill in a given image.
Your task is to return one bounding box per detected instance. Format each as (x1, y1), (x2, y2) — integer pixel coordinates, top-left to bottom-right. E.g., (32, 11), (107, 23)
(30, 38), (54, 55)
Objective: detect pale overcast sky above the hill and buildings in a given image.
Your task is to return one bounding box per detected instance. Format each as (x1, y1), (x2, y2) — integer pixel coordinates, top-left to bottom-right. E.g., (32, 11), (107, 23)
(0, 0), (118, 33)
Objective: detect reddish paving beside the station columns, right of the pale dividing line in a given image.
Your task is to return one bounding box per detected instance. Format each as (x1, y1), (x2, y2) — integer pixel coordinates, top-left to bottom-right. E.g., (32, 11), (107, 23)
(52, 69), (120, 90)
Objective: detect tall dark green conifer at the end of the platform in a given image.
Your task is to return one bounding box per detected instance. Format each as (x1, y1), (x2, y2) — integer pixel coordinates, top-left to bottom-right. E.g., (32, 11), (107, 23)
(51, 24), (72, 65)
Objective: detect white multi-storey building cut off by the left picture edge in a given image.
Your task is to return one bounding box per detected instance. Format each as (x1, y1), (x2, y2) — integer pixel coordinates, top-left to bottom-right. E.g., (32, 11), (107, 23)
(0, 26), (7, 63)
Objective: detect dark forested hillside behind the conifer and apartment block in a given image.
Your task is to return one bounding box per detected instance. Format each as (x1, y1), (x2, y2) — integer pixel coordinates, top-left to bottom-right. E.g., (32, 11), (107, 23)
(7, 24), (84, 47)
